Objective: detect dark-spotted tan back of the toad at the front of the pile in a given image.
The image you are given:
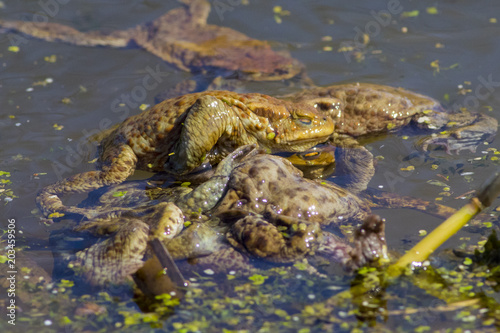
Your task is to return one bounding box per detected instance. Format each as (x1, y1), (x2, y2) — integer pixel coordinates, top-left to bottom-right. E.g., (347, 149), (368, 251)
(216, 155), (369, 225)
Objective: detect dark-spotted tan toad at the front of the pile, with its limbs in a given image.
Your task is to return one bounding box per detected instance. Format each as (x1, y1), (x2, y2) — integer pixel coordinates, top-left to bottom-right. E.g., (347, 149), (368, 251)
(166, 147), (470, 270)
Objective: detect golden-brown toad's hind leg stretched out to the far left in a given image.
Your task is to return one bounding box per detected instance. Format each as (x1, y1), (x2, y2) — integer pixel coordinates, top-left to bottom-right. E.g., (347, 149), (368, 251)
(36, 144), (137, 219)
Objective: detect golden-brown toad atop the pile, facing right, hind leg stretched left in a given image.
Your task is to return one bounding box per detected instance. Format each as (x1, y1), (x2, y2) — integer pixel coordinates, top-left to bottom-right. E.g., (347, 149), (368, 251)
(37, 91), (333, 218)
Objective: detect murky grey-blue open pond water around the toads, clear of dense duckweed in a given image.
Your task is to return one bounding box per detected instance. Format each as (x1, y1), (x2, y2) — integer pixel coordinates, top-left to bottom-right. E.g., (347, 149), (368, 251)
(0, 0), (500, 326)
